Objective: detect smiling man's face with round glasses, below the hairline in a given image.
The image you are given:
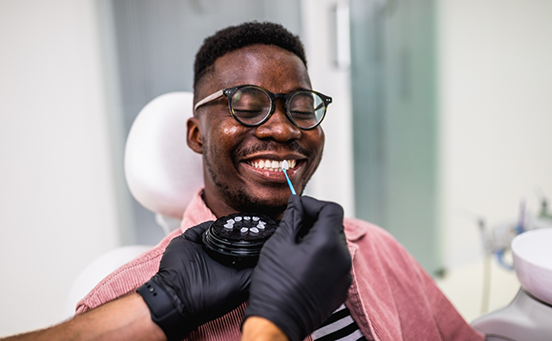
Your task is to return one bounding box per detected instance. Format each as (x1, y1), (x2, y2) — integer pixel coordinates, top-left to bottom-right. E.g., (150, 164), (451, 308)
(188, 39), (329, 218)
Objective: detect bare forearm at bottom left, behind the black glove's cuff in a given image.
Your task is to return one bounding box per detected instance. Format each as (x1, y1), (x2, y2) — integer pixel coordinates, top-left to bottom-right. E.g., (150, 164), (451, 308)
(3, 294), (166, 341)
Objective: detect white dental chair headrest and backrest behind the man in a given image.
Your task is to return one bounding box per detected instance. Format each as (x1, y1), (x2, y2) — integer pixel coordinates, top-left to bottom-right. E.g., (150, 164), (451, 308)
(62, 92), (203, 320)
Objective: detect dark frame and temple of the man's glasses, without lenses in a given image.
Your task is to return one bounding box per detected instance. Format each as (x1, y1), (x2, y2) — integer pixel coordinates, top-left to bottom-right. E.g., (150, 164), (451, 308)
(194, 84), (332, 130)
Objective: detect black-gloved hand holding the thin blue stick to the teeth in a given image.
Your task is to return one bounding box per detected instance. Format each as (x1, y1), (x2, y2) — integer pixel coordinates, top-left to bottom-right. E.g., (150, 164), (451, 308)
(244, 195), (352, 341)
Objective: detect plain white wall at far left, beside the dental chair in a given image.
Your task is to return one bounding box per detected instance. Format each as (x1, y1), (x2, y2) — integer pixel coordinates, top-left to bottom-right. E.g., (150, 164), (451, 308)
(0, 0), (119, 336)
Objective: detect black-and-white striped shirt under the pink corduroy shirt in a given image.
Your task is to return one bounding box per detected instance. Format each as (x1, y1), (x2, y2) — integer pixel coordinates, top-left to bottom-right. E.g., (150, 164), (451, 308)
(312, 304), (366, 341)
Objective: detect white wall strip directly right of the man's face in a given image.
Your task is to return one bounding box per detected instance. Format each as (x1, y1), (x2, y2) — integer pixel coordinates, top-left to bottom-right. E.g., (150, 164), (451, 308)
(301, 0), (355, 217)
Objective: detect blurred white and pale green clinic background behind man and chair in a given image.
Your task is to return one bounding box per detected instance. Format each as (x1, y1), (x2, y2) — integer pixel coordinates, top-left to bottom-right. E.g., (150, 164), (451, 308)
(0, 0), (552, 336)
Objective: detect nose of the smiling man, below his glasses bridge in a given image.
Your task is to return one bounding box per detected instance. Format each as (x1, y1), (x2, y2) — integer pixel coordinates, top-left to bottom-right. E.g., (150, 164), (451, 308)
(255, 101), (301, 143)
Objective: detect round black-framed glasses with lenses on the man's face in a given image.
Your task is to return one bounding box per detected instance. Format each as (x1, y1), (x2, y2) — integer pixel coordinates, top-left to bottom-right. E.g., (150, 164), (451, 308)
(194, 85), (332, 130)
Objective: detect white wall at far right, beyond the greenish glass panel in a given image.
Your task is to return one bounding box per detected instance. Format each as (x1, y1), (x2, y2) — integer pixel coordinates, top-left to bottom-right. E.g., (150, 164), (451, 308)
(437, 0), (552, 319)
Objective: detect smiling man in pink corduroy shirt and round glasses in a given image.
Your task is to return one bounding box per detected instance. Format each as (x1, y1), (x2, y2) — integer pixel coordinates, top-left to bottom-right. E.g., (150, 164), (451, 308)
(77, 23), (480, 340)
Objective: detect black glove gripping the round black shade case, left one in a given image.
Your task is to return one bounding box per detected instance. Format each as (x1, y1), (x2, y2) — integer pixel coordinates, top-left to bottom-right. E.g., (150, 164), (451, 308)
(137, 221), (253, 341)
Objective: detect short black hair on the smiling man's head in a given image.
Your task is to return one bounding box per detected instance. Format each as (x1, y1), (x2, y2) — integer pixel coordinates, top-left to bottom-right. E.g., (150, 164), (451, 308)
(194, 21), (307, 92)
